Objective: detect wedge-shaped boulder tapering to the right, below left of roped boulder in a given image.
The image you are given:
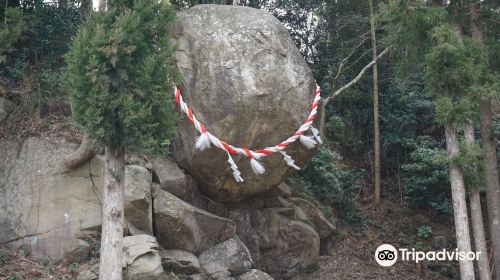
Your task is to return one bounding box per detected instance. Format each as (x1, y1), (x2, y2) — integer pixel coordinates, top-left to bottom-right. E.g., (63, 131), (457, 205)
(153, 188), (236, 254)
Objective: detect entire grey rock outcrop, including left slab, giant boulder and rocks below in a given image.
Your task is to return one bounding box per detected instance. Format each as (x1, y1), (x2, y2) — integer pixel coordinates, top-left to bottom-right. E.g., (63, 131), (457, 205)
(0, 5), (328, 280)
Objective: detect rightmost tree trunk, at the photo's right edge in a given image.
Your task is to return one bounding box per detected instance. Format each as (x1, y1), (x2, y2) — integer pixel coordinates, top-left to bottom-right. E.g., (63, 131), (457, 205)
(469, 3), (500, 280)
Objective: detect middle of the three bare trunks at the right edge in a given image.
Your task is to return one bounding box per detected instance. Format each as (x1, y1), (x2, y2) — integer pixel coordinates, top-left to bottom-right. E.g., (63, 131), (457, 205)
(464, 123), (491, 280)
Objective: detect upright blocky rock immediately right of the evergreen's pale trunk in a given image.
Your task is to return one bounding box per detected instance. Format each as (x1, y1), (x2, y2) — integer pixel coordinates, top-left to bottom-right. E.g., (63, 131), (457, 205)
(124, 165), (153, 235)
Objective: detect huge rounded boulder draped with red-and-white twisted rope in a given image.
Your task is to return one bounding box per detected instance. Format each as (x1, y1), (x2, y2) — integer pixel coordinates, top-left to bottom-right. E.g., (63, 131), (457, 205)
(172, 5), (322, 201)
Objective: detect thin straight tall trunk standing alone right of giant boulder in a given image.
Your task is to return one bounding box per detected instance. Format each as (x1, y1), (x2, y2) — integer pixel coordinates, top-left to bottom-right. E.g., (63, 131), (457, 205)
(368, 0), (380, 206)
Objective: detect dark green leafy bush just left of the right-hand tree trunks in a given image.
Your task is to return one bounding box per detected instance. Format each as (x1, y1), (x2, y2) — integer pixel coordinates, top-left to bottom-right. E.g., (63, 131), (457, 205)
(401, 137), (453, 215)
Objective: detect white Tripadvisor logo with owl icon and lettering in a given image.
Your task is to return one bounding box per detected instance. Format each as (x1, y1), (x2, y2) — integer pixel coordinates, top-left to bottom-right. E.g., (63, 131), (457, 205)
(375, 244), (481, 266)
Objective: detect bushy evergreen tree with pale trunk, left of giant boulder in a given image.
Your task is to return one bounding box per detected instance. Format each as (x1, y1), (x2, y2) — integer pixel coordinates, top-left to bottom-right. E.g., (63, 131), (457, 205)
(66, 0), (178, 280)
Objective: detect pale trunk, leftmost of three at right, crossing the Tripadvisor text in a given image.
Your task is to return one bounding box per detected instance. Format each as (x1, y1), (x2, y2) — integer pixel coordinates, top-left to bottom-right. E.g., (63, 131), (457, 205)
(444, 122), (474, 280)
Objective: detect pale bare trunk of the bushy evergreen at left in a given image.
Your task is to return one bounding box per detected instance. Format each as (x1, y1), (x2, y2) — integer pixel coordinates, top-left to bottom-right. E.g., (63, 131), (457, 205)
(99, 148), (125, 280)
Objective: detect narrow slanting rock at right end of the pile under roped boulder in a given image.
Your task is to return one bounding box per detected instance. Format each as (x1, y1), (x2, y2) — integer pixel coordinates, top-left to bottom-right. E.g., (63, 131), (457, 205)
(288, 197), (335, 239)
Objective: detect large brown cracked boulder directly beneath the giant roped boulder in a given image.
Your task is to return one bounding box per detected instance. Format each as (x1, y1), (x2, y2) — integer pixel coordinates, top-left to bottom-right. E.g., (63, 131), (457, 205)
(230, 208), (320, 279)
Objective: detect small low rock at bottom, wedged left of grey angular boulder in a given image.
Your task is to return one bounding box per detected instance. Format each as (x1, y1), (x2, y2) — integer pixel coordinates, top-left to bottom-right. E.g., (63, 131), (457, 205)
(160, 250), (200, 275)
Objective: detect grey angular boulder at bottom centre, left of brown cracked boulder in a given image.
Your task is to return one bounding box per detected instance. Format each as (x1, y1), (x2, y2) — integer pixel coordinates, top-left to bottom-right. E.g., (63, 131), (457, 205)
(199, 236), (253, 277)
